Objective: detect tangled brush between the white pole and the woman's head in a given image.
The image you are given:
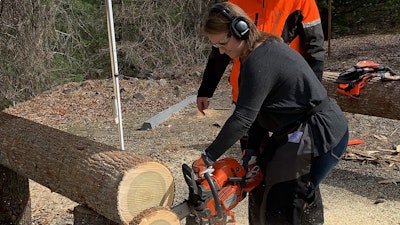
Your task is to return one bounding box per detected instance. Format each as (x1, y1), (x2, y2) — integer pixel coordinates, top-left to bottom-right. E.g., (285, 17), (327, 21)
(115, 0), (216, 76)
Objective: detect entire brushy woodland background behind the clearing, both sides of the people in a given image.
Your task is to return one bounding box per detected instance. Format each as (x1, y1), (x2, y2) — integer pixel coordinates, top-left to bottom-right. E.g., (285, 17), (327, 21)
(0, 0), (400, 109)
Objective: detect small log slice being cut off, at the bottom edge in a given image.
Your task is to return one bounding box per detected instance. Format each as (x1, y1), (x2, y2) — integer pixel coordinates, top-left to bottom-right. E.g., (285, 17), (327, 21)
(129, 207), (180, 225)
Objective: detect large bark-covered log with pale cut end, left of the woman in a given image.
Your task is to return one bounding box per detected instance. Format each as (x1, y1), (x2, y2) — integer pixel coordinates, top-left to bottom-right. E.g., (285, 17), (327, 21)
(0, 112), (174, 224)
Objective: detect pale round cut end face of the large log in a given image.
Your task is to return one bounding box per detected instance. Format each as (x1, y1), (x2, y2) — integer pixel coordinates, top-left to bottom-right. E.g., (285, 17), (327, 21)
(118, 162), (175, 221)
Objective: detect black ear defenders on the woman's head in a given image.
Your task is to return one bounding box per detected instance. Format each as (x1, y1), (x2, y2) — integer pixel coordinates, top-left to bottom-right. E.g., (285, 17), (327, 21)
(210, 4), (250, 40)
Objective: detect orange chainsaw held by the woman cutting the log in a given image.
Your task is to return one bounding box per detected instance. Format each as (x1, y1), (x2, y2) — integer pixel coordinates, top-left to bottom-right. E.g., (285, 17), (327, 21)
(172, 158), (262, 225)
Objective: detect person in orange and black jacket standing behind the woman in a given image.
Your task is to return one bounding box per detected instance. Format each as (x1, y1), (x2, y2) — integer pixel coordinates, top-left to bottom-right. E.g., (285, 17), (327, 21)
(197, 0), (325, 111)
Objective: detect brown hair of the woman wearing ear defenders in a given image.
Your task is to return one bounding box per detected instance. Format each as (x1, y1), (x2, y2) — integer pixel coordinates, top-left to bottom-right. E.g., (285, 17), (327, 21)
(203, 2), (282, 59)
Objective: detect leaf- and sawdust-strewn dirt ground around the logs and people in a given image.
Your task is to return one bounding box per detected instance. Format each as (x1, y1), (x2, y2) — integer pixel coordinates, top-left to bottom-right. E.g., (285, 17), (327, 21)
(5, 35), (400, 225)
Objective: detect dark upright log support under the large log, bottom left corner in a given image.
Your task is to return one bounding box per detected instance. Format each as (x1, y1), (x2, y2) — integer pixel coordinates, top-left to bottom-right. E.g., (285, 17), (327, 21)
(0, 164), (32, 225)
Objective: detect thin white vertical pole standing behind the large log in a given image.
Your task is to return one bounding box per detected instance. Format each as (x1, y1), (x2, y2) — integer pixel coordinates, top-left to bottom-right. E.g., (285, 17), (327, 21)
(106, 0), (125, 150)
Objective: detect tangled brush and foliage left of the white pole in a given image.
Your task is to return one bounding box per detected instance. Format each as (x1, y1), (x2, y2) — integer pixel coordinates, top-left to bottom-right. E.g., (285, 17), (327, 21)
(0, 0), (109, 102)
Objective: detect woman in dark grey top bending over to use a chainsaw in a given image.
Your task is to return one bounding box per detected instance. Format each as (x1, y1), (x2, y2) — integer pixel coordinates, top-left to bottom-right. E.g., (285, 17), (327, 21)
(192, 2), (348, 225)
